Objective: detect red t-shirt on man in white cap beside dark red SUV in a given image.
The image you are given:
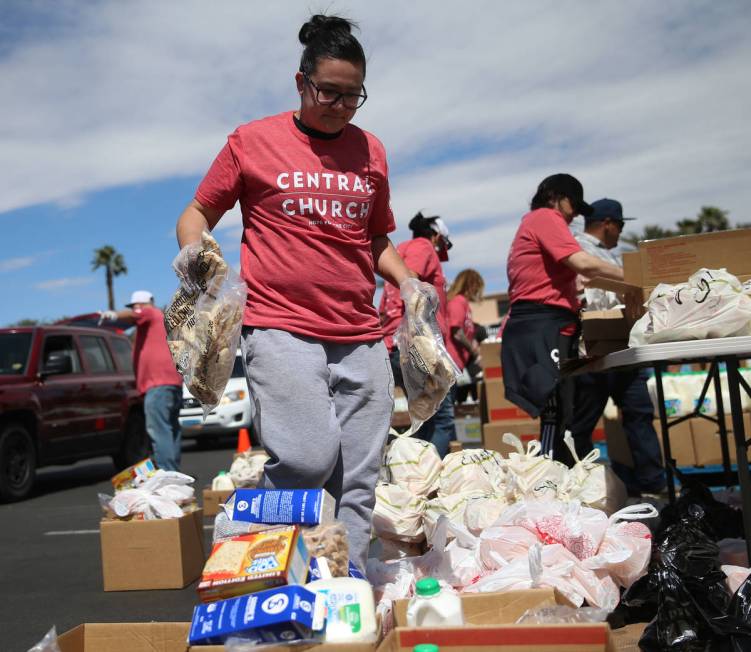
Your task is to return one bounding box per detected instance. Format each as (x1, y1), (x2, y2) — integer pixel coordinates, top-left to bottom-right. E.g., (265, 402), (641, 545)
(133, 307), (183, 394)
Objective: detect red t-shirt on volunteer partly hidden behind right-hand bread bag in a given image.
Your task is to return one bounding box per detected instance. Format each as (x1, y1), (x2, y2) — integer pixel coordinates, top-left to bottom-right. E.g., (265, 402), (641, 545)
(378, 238), (448, 351)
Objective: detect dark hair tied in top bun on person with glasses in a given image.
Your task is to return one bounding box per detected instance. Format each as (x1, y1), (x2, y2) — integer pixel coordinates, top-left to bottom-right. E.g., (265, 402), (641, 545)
(298, 14), (365, 79)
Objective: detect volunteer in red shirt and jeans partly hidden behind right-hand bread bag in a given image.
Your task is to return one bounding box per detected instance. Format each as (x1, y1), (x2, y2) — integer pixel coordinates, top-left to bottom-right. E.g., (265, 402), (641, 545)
(378, 212), (456, 457)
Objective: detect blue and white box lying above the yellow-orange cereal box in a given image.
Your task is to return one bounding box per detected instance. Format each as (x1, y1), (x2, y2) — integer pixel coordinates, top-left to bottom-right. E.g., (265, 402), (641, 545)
(225, 489), (336, 525)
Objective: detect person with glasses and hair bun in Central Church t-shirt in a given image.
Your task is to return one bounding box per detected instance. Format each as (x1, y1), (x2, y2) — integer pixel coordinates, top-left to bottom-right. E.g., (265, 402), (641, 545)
(174, 15), (409, 570)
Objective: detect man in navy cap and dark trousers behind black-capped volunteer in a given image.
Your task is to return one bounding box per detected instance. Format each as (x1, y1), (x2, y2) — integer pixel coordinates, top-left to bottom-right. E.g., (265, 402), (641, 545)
(571, 199), (665, 495)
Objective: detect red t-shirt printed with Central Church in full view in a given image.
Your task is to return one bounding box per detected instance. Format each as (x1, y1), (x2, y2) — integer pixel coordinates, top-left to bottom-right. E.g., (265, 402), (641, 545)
(196, 111), (396, 342)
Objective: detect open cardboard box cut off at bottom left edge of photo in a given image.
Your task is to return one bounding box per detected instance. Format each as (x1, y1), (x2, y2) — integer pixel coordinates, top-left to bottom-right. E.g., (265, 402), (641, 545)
(57, 623), (191, 652)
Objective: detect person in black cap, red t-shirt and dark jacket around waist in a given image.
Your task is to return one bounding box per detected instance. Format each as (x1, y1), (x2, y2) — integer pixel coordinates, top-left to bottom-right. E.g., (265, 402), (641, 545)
(501, 174), (623, 463)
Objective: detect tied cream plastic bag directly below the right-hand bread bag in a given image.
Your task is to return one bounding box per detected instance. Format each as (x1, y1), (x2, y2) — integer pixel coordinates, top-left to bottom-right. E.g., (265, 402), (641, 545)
(381, 428), (442, 496)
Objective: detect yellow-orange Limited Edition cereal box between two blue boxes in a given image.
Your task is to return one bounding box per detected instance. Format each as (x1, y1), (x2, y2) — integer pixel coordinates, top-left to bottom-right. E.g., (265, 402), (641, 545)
(198, 525), (310, 602)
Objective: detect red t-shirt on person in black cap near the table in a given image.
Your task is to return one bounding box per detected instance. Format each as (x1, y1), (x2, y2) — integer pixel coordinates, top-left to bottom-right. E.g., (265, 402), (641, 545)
(506, 208), (581, 312)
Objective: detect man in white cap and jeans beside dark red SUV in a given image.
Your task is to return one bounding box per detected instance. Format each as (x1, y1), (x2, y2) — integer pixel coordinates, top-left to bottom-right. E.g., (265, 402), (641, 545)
(100, 290), (183, 471)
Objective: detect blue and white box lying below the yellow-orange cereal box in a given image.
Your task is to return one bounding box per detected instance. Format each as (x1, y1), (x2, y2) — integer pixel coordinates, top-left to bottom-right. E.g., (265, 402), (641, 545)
(188, 586), (326, 645)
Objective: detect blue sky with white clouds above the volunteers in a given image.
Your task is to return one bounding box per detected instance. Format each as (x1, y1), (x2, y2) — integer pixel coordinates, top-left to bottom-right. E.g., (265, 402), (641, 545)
(0, 0), (751, 325)
